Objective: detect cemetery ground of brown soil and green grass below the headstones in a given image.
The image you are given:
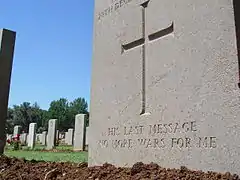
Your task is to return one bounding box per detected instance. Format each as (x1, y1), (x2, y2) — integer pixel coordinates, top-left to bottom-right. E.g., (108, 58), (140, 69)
(0, 145), (239, 180)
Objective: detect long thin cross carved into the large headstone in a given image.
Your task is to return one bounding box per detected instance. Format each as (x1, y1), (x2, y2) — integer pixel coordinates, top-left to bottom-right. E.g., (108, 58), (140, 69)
(122, 0), (174, 115)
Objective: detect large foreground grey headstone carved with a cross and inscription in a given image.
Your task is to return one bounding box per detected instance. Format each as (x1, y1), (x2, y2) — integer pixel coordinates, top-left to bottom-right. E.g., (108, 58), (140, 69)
(88, 0), (240, 174)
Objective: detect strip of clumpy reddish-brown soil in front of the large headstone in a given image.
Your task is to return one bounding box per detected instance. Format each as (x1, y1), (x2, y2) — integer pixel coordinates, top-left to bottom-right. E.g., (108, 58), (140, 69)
(0, 156), (240, 180)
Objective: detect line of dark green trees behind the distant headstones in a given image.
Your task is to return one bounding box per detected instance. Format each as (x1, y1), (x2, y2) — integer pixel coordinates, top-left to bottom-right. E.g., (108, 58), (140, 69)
(6, 97), (89, 134)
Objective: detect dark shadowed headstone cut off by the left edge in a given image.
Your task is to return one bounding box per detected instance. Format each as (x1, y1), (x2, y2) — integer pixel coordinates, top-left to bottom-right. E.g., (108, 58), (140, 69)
(0, 29), (16, 154)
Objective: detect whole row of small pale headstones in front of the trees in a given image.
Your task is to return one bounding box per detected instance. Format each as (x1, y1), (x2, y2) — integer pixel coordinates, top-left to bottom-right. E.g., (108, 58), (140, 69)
(7, 114), (88, 151)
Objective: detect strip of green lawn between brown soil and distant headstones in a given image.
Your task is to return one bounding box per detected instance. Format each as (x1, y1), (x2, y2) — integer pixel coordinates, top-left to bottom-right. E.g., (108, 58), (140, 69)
(5, 146), (88, 163)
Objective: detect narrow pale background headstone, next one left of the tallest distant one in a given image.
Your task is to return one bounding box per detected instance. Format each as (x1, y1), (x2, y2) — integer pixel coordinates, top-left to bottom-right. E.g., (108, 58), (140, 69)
(47, 119), (57, 149)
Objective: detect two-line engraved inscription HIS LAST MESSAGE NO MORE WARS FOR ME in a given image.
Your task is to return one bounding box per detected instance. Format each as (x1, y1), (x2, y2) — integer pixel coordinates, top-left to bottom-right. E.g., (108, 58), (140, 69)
(98, 121), (217, 149)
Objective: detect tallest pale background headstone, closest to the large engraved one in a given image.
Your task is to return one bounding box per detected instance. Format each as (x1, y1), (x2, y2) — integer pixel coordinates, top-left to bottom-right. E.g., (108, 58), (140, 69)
(73, 114), (87, 151)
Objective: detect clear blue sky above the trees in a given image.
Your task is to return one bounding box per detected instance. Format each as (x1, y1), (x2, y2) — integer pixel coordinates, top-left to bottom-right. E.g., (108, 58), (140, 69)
(0, 0), (94, 109)
